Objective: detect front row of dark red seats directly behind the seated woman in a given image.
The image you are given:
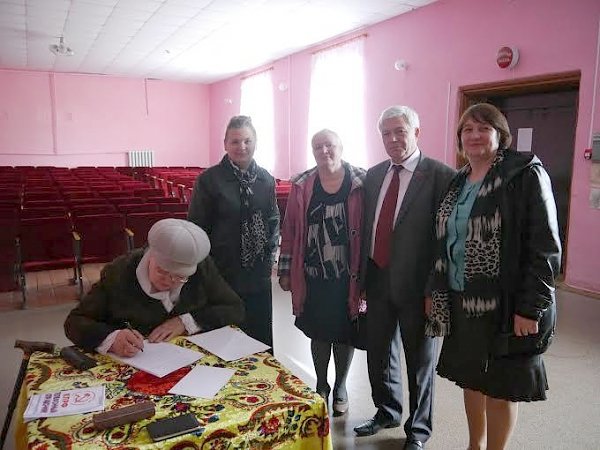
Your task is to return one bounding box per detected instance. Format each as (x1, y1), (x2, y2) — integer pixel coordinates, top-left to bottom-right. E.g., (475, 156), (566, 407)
(0, 211), (187, 306)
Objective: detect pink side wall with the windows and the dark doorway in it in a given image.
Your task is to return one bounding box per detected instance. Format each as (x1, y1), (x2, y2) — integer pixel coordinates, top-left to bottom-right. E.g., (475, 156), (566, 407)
(210, 0), (600, 292)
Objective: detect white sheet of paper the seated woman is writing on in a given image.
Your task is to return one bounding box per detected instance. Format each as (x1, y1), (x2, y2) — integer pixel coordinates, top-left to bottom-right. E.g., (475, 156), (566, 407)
(108, 341), (204, 378)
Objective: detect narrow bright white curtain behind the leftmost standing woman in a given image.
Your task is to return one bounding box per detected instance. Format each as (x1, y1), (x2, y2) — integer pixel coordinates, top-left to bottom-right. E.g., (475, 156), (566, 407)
(240, 70), (275, 172)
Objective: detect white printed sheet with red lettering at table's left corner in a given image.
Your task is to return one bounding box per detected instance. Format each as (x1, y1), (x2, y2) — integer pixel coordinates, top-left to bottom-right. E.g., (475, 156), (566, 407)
(23, 385), (104, 422)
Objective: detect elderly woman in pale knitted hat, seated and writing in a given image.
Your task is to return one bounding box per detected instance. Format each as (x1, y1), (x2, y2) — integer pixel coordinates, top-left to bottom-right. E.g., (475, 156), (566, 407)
(65, 219), (244, 356)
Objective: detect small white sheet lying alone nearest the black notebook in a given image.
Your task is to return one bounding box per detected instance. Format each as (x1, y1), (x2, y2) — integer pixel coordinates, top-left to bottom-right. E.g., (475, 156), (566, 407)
(169, 366), (235, 399)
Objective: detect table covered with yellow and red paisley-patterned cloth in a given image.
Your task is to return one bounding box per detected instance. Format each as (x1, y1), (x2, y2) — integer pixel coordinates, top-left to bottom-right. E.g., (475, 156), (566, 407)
(15, 338), (332, 450)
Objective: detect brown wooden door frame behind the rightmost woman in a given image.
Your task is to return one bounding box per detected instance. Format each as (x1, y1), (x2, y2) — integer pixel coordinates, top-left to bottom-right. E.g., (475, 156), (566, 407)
(456, 70), (581, 278)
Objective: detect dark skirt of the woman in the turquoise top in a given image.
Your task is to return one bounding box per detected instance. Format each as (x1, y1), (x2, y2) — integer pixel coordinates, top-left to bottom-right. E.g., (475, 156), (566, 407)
(437, 293), (548, 402)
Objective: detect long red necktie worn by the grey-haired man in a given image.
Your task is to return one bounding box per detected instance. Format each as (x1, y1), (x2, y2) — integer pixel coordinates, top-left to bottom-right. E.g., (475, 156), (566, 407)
(373, 166), (402, 269)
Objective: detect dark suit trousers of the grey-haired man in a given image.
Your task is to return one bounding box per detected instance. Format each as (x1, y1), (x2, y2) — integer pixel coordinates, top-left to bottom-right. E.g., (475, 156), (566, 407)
(366, 261), (437, 442)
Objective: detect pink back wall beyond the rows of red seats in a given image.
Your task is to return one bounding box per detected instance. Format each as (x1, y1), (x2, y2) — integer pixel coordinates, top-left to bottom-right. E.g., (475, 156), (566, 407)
(0, 70), (209, 167)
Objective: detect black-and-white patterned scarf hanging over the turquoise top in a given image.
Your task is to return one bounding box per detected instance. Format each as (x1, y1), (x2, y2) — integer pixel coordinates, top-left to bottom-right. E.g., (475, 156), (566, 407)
(425, 150), (504, 336)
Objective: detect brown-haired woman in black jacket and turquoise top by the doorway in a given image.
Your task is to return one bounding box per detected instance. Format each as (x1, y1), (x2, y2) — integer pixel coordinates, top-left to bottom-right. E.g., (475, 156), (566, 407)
(426, 104), (561, 450)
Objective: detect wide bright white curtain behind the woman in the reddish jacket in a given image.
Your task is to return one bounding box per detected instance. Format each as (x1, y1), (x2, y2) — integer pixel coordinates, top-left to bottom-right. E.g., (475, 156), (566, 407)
(307, 37), (369, 167)
